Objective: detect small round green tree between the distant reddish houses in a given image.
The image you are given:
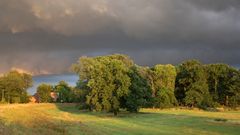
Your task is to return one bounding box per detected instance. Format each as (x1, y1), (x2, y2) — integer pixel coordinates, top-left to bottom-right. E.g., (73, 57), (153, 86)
(37, 84), (53, 103)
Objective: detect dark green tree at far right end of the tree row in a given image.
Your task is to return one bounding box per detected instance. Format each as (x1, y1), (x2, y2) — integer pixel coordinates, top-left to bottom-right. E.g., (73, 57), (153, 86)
(205, 64), (240, 106)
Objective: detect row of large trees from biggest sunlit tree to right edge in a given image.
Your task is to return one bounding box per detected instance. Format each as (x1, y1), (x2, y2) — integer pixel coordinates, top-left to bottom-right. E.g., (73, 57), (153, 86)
(73, 54), (240, 114)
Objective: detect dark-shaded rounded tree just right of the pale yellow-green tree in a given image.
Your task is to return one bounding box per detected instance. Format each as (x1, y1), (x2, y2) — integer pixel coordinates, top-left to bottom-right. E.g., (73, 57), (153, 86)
(175, 60), (211, 107)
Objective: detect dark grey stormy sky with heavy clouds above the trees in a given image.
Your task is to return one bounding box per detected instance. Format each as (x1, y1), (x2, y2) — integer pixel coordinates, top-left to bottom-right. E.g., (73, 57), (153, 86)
(0, 0), (240, 74)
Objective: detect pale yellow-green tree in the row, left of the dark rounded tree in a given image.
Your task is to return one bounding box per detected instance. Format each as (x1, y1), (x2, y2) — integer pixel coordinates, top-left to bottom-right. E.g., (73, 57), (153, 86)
(140, 65), (177, 108)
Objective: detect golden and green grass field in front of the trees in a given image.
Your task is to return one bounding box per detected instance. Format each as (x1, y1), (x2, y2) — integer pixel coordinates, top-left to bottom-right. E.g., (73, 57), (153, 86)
(0, 104), (240, 135)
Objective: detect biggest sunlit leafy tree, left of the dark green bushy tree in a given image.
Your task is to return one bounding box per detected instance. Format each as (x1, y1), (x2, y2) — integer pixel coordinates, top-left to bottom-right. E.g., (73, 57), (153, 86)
(73, 55), (130, 115)
